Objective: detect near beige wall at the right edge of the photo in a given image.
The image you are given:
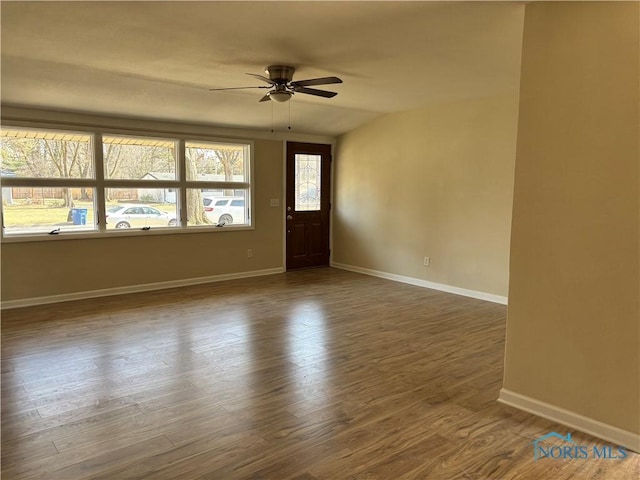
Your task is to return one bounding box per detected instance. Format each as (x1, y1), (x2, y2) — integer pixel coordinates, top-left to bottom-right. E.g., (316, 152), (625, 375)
(504, 2), (640, 432)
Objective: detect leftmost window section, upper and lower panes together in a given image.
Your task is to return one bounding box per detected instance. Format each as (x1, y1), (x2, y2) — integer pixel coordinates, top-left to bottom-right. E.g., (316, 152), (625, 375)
(0, 129), (96, 236)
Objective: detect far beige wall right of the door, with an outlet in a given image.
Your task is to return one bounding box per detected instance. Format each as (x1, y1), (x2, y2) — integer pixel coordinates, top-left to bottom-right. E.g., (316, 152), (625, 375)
(333, 93), (518, 296)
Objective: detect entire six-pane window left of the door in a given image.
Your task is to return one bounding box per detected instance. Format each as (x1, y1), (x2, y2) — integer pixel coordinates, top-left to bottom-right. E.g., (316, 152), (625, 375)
(0, 127), (252, 238)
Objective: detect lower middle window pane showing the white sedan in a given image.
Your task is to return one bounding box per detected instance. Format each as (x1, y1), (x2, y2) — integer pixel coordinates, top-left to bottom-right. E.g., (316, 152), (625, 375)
(105, 188), (179, 230)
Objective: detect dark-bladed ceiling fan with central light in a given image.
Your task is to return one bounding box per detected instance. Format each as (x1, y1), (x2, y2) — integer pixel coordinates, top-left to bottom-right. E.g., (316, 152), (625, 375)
(209, 65), (342, 103)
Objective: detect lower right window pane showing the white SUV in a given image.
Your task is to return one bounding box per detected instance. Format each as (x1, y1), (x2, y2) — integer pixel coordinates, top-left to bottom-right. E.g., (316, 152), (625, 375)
(187, 188), (249, 227)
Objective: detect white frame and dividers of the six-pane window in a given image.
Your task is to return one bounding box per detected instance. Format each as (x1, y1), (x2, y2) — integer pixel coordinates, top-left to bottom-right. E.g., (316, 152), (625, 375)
(0, 121), (255, 243)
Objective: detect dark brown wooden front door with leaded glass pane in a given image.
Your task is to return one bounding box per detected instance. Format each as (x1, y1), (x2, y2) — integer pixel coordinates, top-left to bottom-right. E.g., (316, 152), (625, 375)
(285, 142), (331, 270)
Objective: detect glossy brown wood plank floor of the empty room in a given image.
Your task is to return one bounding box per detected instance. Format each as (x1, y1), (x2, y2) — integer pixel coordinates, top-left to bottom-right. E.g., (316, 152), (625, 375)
(2, 269), (640, 480)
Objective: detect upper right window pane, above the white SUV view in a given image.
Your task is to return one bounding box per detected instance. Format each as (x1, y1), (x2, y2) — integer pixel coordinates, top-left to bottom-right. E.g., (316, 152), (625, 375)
(185, 142), (248, 182)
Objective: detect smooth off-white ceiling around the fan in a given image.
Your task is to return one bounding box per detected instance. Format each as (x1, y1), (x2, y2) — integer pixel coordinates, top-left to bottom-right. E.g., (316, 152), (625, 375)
(0, 1), (524, 136)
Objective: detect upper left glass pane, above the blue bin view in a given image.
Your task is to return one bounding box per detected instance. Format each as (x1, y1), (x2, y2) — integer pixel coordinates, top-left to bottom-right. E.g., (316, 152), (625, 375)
(0, 129), (94, 178)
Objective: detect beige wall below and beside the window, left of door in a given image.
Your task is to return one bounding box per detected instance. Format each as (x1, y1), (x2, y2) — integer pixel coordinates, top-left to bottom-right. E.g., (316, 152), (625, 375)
(1, 120), (283, 301)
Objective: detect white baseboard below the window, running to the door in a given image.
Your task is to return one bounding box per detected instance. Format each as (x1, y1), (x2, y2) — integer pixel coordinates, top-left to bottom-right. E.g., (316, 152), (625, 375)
(0, 267), (285, 310)
